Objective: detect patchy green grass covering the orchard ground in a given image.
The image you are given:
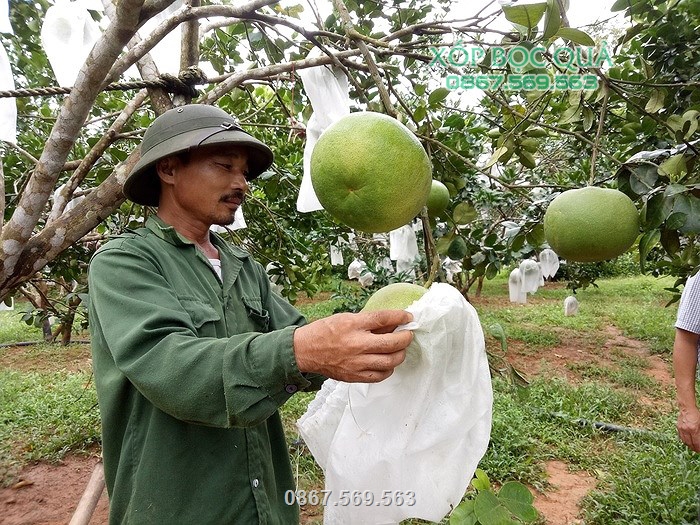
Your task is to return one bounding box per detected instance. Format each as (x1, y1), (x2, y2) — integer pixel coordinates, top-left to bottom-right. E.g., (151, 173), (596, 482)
(0, 276), (700, 525)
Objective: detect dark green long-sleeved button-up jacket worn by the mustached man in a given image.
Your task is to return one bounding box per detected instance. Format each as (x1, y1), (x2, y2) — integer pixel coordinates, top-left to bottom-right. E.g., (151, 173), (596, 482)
(89, 218), (323, 525)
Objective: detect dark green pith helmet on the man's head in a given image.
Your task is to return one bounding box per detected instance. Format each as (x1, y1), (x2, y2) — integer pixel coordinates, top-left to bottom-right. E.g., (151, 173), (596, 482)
(123, 104), (273, 206)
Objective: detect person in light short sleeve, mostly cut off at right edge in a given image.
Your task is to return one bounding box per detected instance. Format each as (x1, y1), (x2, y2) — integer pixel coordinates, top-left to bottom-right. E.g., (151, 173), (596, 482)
(673, 273), (700, 452)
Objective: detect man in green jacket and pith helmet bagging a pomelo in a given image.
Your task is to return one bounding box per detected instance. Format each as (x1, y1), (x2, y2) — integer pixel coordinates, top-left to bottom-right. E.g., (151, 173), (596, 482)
(89, 104), (412, 525)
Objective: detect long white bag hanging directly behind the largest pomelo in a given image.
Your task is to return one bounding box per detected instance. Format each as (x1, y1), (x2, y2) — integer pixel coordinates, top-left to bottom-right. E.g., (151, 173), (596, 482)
(297, 48), (350, 212)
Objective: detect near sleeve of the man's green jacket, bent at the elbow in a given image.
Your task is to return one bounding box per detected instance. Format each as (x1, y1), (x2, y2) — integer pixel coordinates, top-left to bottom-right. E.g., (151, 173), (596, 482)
(89, 247), (312, 427)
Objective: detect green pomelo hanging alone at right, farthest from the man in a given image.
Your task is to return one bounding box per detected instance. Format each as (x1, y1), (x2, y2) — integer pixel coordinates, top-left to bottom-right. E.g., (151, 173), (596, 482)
(544, 186), (639, 262)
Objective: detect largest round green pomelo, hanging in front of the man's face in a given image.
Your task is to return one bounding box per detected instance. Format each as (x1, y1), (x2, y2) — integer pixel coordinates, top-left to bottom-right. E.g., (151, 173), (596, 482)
(311, 112), (432, 233)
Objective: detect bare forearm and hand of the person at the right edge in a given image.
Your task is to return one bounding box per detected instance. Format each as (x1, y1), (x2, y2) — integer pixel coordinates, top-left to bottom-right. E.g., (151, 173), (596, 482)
(673, 328), (700, 452)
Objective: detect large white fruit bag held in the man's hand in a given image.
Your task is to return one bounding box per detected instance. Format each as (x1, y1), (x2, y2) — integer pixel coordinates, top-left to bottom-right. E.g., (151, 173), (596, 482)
(297, 283), (493, 525)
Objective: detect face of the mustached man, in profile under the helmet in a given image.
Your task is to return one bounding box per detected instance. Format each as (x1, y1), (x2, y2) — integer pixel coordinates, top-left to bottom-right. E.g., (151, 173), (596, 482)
(158, 145), (248, 227)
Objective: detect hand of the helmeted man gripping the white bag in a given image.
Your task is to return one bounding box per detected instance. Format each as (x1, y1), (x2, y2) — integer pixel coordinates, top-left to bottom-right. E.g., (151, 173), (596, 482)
(294, 310), (413, 383)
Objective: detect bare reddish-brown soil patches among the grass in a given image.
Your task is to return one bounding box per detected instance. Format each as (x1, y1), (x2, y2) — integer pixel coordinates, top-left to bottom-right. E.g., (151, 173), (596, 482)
(0, 299), (673, 525)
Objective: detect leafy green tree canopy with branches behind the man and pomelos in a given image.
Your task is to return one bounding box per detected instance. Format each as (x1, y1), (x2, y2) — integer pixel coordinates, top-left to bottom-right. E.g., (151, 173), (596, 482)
(0, 0), (700, 320)
